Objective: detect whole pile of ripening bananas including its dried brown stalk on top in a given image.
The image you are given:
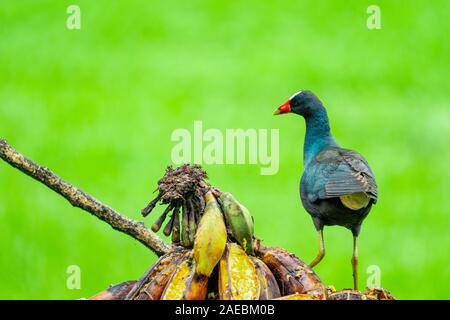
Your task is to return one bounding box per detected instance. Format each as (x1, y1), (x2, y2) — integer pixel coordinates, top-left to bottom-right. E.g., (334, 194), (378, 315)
(90, 165), (394, 300)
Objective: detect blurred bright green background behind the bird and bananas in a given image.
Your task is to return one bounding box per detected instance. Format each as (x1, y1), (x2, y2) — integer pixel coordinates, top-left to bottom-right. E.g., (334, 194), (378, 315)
(0, 0), (450, 299)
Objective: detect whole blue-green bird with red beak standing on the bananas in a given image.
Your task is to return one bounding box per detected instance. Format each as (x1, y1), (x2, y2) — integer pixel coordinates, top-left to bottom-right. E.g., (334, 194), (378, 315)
(274, 91), (378, 290)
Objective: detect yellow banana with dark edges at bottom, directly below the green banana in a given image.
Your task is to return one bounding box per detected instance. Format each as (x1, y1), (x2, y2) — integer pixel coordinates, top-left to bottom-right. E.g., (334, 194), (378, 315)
(219, 243), (260, 300)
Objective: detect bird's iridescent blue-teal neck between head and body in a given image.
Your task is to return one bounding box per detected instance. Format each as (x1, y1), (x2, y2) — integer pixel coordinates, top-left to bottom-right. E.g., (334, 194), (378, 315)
(303, 107), (338, 167)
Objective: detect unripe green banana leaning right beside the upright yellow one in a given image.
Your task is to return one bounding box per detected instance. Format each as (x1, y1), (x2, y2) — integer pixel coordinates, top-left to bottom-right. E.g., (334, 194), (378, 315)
(218, 192), (254, 255)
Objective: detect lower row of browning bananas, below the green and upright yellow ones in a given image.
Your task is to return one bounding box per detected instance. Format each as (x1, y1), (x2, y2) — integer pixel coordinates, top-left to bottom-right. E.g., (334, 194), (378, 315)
(90, 242), (327, 300)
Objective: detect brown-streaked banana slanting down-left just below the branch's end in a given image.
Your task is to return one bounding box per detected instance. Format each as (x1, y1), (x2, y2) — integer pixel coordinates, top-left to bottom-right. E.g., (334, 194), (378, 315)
(127, 250), (188, 300)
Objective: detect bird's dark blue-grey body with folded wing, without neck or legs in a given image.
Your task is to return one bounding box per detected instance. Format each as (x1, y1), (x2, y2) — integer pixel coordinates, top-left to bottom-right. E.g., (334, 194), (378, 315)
(300, 146), (378, 235)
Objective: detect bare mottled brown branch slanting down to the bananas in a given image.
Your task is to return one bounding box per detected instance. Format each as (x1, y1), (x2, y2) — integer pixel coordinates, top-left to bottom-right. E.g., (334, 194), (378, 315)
(0, 140), (171, 256)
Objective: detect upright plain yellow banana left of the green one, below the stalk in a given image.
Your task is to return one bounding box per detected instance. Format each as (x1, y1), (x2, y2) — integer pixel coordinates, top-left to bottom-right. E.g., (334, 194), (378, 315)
(193, 192), (227, 277)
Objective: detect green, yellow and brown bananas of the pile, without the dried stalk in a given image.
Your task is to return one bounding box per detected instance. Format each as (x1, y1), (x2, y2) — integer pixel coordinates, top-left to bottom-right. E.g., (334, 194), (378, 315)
(91, 189), (342, 300)
